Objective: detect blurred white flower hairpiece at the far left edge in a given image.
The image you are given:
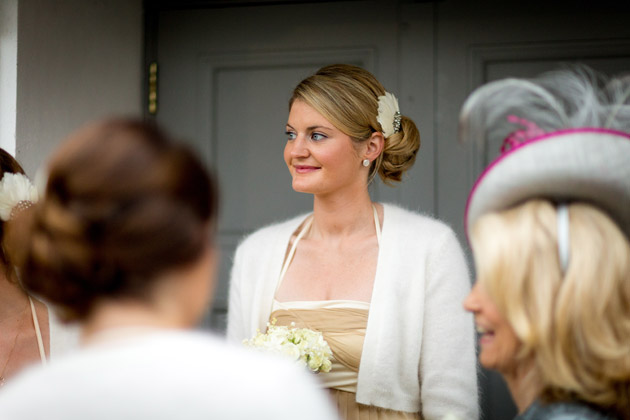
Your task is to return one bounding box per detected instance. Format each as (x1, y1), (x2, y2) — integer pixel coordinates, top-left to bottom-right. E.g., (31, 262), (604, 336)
(0, 172), (39, 222)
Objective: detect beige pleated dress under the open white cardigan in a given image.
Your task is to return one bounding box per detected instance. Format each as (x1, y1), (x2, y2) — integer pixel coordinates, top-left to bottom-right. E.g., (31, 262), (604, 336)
(270, 300), (422, 420)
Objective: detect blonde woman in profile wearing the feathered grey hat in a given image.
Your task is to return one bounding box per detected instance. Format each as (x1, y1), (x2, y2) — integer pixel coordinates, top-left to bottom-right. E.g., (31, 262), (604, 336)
(460, 68), (630, 420)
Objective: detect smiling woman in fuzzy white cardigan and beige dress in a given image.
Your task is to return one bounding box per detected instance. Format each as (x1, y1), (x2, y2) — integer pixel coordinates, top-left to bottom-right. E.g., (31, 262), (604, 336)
(228, 64), (478, 420)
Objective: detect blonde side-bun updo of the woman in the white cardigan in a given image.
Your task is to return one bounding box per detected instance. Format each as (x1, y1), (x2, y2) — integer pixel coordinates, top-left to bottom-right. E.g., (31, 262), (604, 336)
(289, 64), (420, 185)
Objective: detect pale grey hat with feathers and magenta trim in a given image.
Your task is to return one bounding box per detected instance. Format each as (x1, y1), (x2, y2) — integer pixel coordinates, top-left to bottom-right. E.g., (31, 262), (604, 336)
(460, 67), (630, 238)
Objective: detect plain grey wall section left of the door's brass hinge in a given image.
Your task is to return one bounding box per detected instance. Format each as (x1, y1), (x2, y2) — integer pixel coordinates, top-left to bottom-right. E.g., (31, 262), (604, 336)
(16, 0), (143, 176)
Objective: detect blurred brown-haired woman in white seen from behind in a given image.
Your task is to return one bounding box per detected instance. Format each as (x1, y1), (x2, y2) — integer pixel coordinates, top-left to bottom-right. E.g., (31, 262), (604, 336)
(0, 120), (335, 420)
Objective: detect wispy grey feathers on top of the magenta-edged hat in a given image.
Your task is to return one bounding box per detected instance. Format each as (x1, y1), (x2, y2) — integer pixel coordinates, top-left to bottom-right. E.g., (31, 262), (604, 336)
(459, 66), (630, 150)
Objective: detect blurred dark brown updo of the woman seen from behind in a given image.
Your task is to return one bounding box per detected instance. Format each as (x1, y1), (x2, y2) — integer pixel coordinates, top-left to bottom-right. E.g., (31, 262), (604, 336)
(15, 120), (217, 320)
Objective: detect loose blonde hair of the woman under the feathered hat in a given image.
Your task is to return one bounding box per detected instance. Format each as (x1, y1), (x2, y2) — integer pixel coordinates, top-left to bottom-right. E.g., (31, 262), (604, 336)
(471, 199), (630, 419)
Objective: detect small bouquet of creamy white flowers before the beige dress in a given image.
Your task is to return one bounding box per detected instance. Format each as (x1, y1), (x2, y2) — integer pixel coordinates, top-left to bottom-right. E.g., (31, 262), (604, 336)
(243, 319), (332, 372)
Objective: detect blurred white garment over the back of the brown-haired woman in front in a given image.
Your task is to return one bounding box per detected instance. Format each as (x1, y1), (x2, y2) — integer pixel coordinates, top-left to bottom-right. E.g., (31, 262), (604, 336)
(0, 331), (340, 420)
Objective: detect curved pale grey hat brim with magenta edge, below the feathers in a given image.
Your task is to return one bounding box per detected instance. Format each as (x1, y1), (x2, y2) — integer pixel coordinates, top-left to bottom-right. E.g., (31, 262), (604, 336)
(465, 128), (630, 238)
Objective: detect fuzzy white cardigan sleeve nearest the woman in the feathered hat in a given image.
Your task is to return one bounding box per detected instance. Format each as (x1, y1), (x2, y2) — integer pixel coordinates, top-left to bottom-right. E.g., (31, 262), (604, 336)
(419, 228), (479, 420)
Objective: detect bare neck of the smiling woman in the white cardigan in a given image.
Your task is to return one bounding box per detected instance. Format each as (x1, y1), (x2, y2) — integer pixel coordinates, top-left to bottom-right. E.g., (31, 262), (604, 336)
(311, 189), (374, 239)
